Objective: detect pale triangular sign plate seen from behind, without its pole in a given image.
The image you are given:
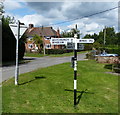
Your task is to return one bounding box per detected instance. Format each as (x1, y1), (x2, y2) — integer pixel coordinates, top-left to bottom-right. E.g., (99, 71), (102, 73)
(9, 24), (27, 39)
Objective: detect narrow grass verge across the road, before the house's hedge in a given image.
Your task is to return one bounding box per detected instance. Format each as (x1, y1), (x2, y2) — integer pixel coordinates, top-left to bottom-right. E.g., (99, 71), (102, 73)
(25, 51), (88, 57)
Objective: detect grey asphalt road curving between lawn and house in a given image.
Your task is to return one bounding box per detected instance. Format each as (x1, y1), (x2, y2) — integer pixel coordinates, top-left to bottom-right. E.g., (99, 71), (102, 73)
(0, 54), (85, 81)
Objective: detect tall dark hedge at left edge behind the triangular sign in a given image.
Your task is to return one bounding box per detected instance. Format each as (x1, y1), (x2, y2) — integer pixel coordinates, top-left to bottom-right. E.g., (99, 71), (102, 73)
(2, 16), (25, 61)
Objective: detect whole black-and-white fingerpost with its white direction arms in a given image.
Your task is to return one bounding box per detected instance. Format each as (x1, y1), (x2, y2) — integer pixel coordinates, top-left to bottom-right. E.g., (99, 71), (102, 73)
(50, 34), (94, 106)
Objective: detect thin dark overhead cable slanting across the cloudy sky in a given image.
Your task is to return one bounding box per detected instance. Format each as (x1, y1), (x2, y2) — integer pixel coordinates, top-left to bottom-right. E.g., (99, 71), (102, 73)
(44, 6), (120, 26)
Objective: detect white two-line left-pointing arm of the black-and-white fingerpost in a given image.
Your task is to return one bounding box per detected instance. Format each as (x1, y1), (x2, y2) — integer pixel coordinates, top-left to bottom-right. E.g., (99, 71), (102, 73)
(50, 38), (74, 45)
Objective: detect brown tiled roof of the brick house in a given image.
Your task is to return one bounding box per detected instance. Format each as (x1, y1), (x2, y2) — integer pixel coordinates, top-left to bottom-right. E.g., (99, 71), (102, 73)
(25, 27), (57, 37)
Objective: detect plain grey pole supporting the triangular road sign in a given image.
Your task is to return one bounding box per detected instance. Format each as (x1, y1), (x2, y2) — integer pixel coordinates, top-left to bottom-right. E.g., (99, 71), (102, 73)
(15, 20), (20, 85)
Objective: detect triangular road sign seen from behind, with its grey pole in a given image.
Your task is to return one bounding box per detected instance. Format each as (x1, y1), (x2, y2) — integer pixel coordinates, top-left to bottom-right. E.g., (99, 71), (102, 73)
(9, 20), (27, 85)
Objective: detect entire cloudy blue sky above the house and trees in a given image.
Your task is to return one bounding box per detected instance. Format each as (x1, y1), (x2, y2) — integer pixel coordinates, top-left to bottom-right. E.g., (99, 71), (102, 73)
(4, 0), (118, 37)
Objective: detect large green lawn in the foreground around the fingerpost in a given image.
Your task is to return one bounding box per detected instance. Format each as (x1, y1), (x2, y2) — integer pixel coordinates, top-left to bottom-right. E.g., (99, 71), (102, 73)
(2, 60), (118, 113)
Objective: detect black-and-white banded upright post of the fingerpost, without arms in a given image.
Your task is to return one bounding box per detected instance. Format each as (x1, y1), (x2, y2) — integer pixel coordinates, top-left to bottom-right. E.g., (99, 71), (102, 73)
(74, 34), (77, 106)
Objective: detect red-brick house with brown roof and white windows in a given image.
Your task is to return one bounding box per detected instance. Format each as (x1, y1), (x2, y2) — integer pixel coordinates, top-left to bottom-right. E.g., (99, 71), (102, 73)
(25, 24), (63, 51)
